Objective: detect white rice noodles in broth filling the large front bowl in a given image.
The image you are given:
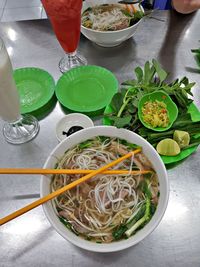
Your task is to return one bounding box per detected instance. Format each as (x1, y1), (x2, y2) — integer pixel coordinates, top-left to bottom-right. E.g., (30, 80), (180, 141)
(51, 137), (158, 242)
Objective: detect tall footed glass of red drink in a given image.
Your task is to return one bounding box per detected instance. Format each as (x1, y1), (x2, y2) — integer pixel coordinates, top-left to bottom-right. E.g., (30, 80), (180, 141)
(42, 0), (87, 72)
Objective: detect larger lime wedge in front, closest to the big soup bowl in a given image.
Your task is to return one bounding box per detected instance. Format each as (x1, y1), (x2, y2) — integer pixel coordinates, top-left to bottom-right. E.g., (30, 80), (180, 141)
(156, 138), (181, 156)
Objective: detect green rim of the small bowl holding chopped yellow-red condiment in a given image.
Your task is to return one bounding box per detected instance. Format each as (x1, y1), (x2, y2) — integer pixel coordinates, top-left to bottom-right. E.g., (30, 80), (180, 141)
(138, 90), (178, 132)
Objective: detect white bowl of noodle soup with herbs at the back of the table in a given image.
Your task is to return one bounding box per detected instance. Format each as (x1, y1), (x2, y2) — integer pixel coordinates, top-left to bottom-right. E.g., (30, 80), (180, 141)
(81, 1), (144, 47)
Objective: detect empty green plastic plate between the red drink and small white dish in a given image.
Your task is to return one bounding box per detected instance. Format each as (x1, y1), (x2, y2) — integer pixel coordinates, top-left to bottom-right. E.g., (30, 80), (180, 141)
(56, 66), (118, 112)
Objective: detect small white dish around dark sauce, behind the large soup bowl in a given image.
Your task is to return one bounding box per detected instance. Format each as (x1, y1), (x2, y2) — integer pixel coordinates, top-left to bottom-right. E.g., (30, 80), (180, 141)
(56, 113), (94, 142)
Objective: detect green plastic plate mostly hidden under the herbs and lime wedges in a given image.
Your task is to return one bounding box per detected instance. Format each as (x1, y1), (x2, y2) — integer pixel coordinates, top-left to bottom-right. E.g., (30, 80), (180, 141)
(103, 103), (200, 164)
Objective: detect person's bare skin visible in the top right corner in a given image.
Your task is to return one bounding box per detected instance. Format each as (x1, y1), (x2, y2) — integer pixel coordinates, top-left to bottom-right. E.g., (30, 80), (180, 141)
(172, 0), (200, 14)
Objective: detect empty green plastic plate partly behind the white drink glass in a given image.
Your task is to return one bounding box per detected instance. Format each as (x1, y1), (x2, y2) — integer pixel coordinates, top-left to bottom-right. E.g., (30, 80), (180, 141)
(14, 68), (55, 114)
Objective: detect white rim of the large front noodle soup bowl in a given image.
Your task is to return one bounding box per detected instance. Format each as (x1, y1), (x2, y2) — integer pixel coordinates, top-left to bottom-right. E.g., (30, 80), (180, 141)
(40, 126), (169, 253)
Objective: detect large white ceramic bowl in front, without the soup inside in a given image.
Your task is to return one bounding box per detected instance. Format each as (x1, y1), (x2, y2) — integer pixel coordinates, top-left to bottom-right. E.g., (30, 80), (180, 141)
(41, 126), (169, 252)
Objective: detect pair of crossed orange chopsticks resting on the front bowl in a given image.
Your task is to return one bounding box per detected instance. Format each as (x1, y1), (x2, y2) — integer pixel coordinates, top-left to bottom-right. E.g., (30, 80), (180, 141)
(0, 148), (144, 225)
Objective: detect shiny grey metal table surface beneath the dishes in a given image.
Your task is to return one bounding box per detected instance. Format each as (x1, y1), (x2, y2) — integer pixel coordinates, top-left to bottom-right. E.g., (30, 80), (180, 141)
(0, 11), (200, 267)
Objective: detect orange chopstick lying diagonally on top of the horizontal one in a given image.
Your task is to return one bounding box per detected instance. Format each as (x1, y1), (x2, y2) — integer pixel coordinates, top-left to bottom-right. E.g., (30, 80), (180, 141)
(0, 149), (141, 225)
